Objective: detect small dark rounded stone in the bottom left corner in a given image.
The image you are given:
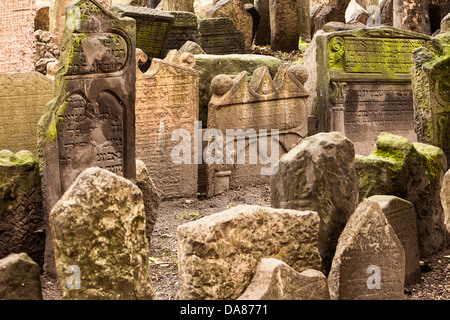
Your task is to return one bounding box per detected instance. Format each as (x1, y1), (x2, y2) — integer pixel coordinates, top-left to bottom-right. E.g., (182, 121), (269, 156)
(0, 253), (43, 300)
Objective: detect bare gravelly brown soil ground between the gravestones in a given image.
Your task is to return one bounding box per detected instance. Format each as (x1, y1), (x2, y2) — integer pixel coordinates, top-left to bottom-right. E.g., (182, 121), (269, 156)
(41, 186), (450, 300)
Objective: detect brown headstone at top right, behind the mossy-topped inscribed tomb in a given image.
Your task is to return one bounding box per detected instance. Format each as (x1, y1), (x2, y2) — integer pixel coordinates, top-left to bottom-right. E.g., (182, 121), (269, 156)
(393, 0), (431, 35)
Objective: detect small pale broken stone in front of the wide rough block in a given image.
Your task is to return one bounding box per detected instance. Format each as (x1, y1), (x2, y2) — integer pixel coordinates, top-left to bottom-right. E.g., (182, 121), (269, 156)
(237, 258), (330, 300)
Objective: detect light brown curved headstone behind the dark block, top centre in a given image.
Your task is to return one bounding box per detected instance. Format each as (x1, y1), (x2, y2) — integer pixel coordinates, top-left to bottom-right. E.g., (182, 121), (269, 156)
(206, 0), (253, 50)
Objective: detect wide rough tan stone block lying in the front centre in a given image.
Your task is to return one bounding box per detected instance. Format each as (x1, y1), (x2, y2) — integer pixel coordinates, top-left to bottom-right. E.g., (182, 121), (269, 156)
(177, 205), (321, 300)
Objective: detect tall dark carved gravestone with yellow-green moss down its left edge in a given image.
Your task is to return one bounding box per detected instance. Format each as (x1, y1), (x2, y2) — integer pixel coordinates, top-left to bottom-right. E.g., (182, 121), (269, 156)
(38, 0), (136, 272)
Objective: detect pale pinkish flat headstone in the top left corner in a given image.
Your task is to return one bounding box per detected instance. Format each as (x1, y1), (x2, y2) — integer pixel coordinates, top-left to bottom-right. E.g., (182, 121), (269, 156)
(0, 0), (36, 73)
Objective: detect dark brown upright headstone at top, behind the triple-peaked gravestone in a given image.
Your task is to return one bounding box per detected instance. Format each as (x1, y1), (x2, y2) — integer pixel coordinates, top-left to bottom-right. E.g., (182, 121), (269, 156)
(269, 0), (300, 51)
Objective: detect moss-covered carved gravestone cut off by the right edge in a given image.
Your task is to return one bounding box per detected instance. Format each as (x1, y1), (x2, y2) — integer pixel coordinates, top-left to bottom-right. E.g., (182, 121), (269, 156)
(412, 32), (450, 163)
